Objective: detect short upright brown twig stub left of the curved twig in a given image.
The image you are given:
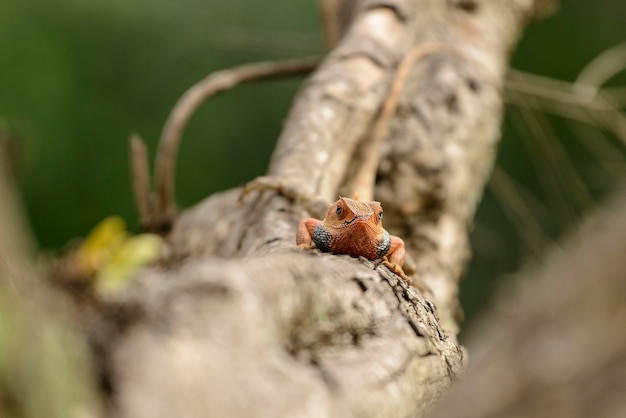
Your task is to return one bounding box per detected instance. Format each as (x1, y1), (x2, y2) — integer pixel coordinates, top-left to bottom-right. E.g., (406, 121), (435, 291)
(130, 134), (153, 228)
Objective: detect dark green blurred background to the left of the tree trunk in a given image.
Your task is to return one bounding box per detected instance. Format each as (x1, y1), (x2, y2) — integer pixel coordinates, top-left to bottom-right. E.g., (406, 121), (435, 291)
(0, 0), (321, 248)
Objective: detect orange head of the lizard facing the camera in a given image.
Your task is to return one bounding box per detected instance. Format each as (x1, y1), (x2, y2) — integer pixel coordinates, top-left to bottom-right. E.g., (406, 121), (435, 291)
(323, 195), (383, 234)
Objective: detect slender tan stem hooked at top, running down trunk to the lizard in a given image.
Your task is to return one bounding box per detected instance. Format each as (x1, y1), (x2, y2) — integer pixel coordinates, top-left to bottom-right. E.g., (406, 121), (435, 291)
(353, 42), (462, 200)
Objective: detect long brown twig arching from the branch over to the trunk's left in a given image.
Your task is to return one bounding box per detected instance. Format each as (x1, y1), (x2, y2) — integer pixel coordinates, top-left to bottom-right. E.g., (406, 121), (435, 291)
(152, 58), (319, 229)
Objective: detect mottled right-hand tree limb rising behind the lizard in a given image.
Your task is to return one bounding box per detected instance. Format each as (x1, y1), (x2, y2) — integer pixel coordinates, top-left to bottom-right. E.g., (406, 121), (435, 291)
(375, 1), (533, 332)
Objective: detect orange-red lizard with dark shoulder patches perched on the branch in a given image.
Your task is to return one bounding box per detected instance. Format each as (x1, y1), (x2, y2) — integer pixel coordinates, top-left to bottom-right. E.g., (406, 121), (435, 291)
(296, 194), (411, 284)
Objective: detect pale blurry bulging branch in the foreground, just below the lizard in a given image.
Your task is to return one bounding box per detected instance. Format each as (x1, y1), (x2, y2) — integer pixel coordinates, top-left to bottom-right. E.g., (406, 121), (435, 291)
(111, 250), (461, 417)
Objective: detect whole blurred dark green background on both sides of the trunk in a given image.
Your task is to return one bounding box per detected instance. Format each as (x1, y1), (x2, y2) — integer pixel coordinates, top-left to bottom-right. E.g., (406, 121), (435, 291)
(0, 0), (626, 330)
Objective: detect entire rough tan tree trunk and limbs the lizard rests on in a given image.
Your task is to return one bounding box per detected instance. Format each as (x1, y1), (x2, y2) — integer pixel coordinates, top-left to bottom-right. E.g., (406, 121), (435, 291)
(77, 0), (548, 417)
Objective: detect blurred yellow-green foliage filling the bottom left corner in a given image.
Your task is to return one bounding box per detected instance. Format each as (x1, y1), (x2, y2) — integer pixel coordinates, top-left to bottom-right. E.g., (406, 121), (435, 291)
(0, 282), (100, 418)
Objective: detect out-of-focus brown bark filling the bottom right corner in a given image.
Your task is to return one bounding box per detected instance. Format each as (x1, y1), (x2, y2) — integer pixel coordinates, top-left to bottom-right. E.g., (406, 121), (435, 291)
(433, 195), (626, 418)
